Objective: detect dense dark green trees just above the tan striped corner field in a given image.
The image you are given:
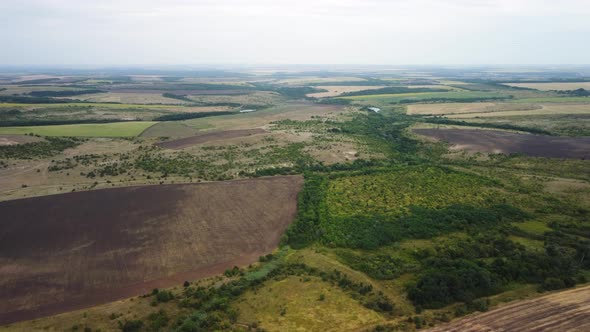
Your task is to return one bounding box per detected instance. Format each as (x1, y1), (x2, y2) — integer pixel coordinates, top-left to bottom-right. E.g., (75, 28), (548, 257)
(408, 231), (587, 308)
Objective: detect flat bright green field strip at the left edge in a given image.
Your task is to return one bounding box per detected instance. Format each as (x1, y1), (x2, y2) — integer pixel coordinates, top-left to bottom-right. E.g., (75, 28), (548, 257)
(0, 121), (157, 137)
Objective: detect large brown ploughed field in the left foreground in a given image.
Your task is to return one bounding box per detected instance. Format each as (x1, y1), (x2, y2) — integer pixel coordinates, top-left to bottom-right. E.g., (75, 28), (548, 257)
(0, 176), (303, 324)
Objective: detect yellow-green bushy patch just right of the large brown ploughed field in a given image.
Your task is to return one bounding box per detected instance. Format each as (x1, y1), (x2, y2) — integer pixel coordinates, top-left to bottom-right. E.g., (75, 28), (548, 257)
(327, 166), (498, 217)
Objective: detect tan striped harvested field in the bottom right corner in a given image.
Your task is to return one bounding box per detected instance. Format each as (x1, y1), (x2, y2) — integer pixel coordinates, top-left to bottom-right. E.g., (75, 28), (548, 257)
(429, 286), (590, 332)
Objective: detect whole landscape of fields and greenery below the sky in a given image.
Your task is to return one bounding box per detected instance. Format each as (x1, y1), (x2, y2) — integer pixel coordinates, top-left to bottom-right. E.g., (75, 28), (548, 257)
(0, 66), (590, 332)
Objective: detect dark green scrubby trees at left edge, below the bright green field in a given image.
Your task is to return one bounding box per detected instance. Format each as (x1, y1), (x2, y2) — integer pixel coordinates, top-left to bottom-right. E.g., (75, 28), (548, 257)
(0, 137), (82, 159)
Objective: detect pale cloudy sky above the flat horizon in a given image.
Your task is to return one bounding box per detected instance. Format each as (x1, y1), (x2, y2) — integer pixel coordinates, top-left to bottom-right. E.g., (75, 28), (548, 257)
(0, 0), (590, 66)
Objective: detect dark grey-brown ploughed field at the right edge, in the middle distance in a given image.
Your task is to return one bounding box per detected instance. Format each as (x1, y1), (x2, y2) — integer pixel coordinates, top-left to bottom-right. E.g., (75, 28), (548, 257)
(413, 129), (590, 159)
